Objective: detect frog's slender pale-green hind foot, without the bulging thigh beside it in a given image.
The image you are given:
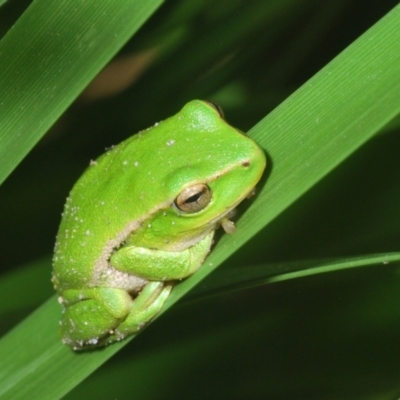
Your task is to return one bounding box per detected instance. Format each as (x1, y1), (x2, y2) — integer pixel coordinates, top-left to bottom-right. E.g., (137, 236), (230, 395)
(104, 282), (172, 344)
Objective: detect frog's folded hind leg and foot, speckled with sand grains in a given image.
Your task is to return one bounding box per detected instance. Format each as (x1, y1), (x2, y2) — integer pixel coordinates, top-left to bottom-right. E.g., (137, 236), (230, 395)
(60, 282), (172, 350)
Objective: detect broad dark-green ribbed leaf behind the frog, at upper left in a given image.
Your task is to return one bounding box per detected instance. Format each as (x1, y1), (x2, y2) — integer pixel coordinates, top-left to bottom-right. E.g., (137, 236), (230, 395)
(0, 0), (162, 187)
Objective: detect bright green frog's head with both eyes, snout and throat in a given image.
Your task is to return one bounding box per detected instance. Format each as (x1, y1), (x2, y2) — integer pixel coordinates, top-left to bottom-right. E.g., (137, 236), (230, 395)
(128, 100), (266, 251)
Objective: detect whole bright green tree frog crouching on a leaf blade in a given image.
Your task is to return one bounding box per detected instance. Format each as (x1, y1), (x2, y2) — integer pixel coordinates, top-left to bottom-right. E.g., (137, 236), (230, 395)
(52, 100), (266, 350)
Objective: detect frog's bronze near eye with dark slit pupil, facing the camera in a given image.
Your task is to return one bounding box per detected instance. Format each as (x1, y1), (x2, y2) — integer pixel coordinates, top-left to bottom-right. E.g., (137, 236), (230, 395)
(174, 183), (212, 214)
